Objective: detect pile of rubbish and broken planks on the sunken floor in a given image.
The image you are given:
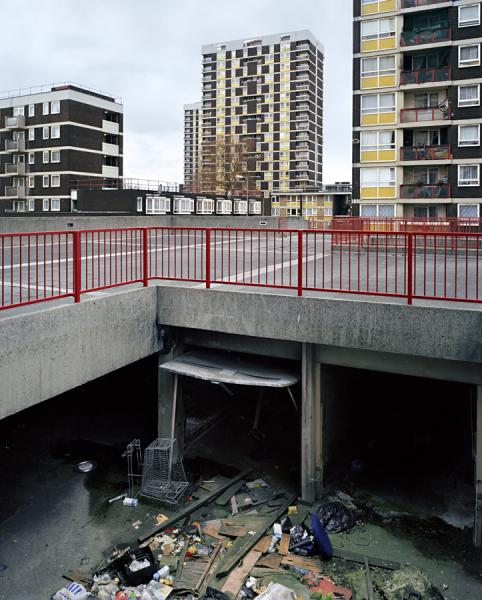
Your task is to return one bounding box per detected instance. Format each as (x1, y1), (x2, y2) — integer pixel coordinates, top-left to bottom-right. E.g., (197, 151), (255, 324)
(52, 471), (443, 600)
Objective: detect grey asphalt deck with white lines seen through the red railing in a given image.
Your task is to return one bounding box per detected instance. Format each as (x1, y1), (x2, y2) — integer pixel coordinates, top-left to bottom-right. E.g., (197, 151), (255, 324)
(0, 230), (482, 318)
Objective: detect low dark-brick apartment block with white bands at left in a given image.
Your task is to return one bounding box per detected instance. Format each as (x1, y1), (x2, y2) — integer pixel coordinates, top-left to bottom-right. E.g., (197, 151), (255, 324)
(0, 83), (123, 214)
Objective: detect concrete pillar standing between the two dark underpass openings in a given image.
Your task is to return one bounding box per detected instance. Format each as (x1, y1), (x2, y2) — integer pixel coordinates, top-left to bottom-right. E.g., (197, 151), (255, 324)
(301, 343), (322, 503)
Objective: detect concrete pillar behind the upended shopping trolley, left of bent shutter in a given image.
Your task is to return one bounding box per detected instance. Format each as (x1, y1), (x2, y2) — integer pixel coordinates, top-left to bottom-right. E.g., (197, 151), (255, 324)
(157, 345), (184, 452)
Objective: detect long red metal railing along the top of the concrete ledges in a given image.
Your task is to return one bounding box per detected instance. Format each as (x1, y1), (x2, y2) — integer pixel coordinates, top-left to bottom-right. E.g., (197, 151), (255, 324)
(0, 225), (482, 309)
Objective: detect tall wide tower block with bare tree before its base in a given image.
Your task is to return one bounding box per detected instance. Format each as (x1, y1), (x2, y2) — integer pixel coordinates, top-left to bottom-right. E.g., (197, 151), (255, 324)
(201, 31), (323, 197)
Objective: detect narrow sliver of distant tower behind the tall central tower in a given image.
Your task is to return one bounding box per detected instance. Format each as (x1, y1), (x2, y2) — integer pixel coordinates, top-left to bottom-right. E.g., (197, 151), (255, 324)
(184, 102), (202, 192)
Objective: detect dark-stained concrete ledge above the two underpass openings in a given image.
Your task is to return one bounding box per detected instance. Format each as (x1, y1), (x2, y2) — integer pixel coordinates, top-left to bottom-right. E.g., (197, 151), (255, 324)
(157, 286), (482, 364)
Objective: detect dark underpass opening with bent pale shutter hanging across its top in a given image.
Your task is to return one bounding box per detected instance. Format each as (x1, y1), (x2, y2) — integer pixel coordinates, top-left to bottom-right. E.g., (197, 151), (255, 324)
(161, 348), (301, 491)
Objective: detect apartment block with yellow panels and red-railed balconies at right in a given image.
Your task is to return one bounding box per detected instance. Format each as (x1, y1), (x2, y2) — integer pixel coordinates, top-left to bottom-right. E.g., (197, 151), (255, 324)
(353, 0), (482, 217)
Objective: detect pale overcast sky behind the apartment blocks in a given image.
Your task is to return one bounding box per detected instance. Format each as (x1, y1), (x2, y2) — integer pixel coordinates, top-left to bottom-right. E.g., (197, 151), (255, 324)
(0, 0), (352, 183)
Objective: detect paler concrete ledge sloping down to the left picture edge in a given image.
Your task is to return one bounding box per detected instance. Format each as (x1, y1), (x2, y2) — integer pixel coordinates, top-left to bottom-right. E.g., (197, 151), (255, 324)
(0, 288), (158, 419)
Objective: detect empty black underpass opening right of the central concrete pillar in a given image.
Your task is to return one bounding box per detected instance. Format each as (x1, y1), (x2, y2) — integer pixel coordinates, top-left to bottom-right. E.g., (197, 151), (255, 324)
(323, 367), (475, 528)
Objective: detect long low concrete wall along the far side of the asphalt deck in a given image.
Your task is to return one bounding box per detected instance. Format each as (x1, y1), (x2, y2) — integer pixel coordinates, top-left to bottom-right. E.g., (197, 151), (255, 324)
(0, 213), (308, 233)
